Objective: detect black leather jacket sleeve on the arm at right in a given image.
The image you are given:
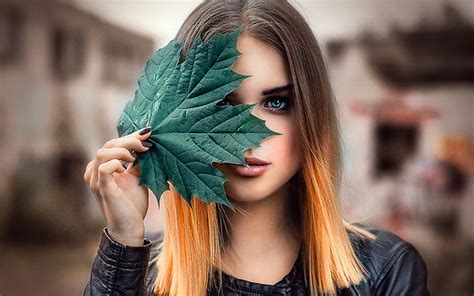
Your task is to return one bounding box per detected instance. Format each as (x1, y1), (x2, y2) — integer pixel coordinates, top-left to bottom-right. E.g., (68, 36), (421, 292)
(375, 246), (431, 296)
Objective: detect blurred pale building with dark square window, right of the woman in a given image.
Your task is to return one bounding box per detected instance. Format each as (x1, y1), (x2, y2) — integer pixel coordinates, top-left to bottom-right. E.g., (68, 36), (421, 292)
(326, 3), (474, 239)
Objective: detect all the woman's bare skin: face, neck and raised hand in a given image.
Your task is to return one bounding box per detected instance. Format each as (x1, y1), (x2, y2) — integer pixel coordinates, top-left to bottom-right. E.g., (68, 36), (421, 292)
(84, 33), (301, 284)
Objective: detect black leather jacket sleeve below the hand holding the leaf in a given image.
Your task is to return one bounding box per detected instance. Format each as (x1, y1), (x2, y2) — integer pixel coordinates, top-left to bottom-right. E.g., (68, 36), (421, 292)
(83, 227), (152, 296)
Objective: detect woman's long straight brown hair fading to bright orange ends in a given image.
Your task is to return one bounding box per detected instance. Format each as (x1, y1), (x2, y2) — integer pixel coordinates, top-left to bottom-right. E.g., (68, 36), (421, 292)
(154, 0), (375, 295)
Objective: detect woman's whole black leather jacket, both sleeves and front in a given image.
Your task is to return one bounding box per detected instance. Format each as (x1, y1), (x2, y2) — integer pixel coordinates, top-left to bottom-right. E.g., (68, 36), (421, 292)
(84, 224), (431, 296)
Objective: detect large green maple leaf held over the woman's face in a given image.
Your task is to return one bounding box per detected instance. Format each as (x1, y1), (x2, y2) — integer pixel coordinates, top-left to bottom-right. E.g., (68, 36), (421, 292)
(117, 26), (281, 209)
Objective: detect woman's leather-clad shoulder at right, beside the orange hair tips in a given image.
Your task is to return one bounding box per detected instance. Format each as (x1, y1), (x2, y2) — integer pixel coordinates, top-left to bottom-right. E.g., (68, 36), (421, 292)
(349, 223), (429, 295)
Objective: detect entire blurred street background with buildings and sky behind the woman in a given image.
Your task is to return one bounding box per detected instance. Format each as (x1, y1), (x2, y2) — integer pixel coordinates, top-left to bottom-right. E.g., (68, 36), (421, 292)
(0, 0), (474, 296)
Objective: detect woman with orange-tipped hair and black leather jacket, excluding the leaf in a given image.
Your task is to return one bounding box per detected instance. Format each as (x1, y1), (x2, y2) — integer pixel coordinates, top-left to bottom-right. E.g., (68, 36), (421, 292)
(84, 0), (429, 295)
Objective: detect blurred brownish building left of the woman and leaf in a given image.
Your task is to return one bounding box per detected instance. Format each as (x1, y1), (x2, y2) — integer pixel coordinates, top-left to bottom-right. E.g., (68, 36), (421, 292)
(0, 0), (154, 241)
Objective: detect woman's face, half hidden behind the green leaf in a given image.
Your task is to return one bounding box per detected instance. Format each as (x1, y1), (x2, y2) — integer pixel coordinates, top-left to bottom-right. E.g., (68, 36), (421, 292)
(213, 33), (300, 201)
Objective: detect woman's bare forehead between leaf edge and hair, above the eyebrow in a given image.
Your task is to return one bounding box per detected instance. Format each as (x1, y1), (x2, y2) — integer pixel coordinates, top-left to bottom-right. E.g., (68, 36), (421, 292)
(233, 33), (290, 97)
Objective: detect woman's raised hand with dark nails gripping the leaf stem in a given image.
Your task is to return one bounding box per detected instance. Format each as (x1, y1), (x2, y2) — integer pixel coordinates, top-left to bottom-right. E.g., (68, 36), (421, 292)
(84, 128), (151, 246)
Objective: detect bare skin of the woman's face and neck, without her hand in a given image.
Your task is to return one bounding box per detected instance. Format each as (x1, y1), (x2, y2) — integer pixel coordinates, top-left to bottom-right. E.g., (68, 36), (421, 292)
(214, 33), (300, 284)
